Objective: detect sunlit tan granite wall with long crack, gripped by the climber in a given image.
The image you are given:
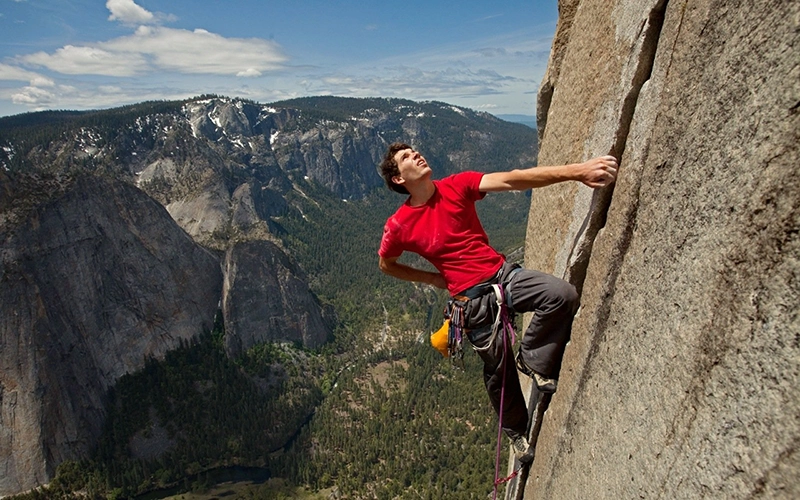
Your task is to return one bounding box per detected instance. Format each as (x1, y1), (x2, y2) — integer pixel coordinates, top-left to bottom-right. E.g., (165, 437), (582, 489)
(518, 0), (800, 499)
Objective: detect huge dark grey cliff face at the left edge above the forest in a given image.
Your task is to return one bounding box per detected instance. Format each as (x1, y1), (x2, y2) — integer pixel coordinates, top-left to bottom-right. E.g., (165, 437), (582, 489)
(0, 177), (222, 495)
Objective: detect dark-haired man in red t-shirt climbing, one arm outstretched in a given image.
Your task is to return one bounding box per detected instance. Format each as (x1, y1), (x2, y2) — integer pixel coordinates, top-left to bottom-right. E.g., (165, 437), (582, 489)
(378, 143), (617, 461)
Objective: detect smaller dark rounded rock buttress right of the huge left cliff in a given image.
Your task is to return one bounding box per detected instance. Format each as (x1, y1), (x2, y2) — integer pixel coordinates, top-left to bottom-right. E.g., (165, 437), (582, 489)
(222, 241), (333, 356)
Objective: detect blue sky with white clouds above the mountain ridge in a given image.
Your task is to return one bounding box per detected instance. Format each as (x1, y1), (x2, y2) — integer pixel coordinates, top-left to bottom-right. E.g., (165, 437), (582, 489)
(0, 0), (558, 116)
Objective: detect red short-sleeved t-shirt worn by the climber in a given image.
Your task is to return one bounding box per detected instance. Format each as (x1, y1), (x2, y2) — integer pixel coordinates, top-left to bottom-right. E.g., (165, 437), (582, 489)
(378, 172), (505, 295)
